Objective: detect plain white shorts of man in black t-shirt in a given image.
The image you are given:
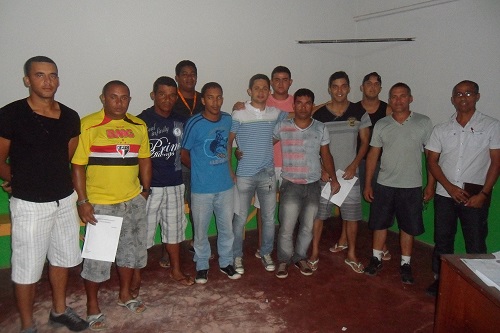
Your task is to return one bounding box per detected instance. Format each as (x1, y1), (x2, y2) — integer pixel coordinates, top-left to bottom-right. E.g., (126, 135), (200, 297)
(10, 192), (82, 284)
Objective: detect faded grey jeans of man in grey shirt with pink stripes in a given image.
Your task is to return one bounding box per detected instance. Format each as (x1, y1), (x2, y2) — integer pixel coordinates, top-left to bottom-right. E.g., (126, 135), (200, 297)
(278, 179), (321, 264)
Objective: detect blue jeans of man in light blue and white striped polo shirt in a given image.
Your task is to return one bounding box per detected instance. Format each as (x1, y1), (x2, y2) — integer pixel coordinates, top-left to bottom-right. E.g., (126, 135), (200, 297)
(233, 168), (276, 258)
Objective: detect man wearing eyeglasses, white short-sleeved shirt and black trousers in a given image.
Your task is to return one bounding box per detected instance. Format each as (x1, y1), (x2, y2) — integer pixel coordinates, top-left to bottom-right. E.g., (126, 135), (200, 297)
(425, 80), (500, 296)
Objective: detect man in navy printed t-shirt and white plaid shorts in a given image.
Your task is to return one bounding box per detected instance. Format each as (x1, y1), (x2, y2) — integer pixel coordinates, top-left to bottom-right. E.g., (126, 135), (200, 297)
(138, 76), (194, 286)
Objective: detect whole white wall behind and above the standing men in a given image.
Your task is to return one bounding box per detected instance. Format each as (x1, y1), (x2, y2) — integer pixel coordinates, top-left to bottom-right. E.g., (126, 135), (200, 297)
(0, 0), (500, 122)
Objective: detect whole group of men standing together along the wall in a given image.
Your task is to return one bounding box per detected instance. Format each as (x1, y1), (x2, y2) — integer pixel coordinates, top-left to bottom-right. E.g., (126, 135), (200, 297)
(0, 56), (500, 332)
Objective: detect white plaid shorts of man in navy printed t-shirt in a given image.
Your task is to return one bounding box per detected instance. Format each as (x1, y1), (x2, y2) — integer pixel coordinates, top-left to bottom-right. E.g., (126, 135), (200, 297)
(146, 184), (187, 249)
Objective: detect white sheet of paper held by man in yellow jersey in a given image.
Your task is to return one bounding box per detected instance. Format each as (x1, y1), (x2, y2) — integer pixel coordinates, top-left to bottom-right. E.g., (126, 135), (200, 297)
(82, 215), (123, 262)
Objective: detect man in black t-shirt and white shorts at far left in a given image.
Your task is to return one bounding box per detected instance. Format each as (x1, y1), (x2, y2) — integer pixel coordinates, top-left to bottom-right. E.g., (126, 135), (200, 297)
(0, 56), (88, 332)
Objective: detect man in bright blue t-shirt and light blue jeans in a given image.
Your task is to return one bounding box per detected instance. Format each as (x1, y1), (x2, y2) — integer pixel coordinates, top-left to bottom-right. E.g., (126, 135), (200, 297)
(181, 82), (241, 284)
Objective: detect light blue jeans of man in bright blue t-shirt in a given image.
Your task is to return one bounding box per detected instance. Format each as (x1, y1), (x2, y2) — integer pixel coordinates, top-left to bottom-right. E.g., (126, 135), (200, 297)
(191, 187), (234, 271)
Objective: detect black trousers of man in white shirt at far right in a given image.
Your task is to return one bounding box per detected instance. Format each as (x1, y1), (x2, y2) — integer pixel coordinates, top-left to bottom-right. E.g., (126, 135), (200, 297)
(432, 195), (489, 274)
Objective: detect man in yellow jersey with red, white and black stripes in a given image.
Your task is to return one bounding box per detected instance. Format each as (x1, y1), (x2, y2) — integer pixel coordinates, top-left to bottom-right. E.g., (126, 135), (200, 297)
(72, 81), (151, 330)
